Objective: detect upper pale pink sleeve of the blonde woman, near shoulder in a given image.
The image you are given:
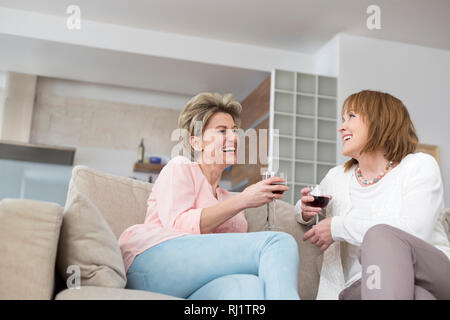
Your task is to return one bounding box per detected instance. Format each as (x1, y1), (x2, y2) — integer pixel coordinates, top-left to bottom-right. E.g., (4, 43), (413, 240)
(153, 158), (202, 234)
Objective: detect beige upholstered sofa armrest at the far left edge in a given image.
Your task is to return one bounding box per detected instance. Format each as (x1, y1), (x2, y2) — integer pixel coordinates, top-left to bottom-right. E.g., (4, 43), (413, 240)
(0, 199), (63, 300)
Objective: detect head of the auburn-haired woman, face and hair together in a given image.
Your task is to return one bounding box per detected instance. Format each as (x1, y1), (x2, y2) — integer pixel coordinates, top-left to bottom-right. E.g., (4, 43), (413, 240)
(339, 90), (418, 171)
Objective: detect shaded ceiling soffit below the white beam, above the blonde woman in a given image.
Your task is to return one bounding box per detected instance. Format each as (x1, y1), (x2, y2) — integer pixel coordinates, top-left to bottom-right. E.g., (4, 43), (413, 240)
(0, 34), (269, 100)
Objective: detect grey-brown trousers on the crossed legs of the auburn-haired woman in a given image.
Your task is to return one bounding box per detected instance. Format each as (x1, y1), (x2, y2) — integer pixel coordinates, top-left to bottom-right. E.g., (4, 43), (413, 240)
(339, 224), (450, 300)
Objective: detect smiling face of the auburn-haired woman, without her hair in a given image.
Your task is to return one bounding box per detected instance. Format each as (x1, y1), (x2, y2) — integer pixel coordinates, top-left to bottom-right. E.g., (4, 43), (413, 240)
(338, 110), (368, 159)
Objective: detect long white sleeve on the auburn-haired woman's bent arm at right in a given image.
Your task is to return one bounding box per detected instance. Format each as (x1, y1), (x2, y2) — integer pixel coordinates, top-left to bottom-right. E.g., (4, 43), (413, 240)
(331, 155), (443, 246)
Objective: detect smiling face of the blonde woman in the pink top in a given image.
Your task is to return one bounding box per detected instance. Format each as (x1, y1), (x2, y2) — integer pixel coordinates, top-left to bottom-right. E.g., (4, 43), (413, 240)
(193, 112), (238, 167)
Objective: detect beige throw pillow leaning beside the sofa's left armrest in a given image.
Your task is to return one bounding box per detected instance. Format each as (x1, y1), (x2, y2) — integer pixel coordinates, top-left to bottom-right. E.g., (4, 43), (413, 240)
(57, 190), (126, 288)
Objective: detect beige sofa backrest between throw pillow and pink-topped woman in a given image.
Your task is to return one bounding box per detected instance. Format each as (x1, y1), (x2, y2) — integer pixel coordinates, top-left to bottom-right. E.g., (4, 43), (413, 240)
(67, 166), (153, 239)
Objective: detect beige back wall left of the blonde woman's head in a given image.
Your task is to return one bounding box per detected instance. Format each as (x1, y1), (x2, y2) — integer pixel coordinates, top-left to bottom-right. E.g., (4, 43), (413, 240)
(30, 77), (182, 181)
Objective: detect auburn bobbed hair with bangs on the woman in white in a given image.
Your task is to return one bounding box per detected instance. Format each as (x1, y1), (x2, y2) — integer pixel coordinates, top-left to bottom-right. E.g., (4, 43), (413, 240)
(342, 90), (418, 171)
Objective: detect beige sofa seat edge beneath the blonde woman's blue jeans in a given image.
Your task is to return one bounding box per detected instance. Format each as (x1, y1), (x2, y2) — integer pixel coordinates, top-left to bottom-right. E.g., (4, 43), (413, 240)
(55, 286), (182, 300)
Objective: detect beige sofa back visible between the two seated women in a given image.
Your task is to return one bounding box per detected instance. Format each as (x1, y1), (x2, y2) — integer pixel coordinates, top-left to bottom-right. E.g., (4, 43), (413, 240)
(245, 200), (322, 300)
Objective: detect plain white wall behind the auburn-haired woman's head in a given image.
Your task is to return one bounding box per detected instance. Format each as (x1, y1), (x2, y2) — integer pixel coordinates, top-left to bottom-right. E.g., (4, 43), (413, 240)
(338, 35), (450, 206)
